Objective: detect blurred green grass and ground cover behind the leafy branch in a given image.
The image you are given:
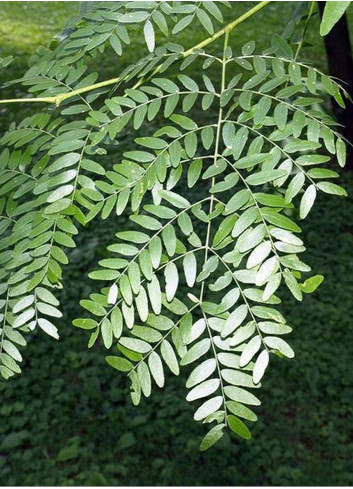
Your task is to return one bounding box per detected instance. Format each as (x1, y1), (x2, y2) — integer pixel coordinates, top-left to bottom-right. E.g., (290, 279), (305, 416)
(0, 1), (353, 486)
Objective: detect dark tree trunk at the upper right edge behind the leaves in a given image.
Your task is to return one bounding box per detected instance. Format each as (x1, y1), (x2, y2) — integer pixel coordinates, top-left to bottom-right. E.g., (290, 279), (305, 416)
(317, 2), (353, 170)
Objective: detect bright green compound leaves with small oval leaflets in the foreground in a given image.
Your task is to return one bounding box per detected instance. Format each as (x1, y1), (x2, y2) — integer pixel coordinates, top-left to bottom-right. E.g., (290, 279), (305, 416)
(0, 2), (345, 450)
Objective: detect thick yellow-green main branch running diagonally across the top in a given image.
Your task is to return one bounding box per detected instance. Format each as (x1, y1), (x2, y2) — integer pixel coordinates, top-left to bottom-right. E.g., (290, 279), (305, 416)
(0, 0), (271, 107)
